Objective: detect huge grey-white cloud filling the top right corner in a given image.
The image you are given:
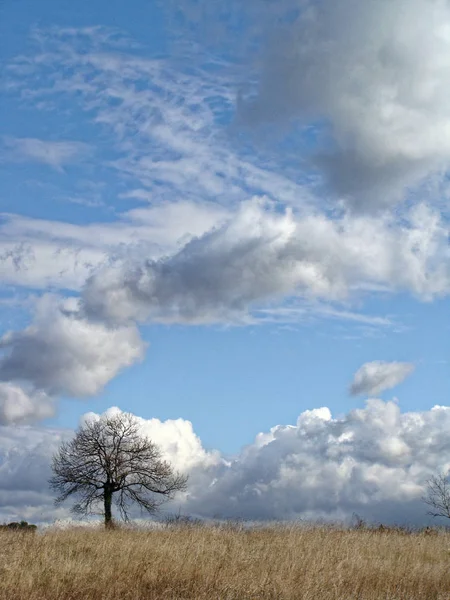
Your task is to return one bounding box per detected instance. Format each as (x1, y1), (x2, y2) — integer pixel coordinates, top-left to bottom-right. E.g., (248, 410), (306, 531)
(232, 0), (450, 209)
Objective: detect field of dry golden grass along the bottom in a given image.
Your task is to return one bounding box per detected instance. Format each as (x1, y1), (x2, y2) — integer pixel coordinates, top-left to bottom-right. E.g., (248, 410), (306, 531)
(0, 526), (450, 600)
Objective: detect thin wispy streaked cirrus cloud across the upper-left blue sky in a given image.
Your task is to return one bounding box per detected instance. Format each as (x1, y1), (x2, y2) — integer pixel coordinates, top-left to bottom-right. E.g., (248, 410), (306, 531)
(8, 28), (316, 213)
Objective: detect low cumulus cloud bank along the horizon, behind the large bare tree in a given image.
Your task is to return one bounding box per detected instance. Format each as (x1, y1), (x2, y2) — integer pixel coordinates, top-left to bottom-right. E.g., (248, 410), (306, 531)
(0, 400), (450, 524)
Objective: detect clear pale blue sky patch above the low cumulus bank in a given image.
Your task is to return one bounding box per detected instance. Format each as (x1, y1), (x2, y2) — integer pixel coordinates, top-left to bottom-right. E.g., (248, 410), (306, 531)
(52, 298), (449, 453)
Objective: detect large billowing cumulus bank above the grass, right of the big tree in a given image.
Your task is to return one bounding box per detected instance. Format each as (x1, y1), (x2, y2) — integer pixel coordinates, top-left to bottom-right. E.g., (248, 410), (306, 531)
(186, 400), (450, 524)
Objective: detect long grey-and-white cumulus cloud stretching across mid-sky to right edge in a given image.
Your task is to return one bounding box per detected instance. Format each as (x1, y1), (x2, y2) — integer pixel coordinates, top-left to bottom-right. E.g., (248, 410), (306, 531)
(83, 199), (450, 323)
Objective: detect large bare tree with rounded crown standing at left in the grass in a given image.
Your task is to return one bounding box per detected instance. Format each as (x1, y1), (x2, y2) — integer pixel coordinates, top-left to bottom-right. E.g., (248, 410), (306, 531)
(49, 413), (187, 527)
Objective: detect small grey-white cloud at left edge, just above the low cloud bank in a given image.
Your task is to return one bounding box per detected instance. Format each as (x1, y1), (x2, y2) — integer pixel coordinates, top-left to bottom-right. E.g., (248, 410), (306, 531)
(0, 383), (55, 425)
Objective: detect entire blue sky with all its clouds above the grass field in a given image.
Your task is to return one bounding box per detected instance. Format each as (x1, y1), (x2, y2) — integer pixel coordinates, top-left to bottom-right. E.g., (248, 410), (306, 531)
(0, 0), (450, 524)
